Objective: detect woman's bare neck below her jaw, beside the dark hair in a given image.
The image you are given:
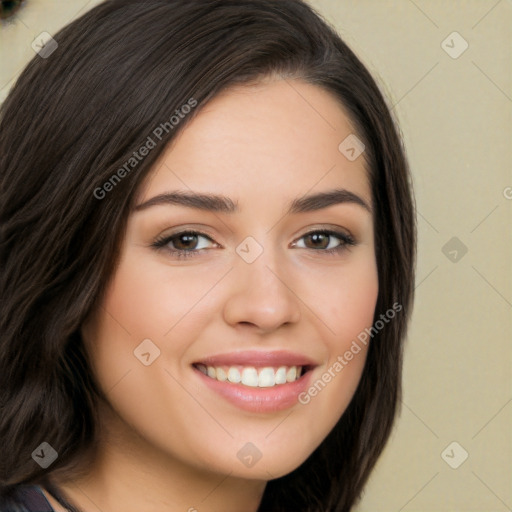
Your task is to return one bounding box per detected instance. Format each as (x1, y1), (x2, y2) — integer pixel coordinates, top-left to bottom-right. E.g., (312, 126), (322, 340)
(46, 400), (266, 512)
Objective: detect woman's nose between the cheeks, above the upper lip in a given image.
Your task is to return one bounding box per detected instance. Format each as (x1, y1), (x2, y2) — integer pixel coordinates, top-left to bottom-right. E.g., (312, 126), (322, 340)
(224, 244), (301, 333)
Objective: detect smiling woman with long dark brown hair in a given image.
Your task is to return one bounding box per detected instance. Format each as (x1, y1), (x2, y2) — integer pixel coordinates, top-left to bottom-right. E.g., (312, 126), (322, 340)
(0, 0), (415, 512)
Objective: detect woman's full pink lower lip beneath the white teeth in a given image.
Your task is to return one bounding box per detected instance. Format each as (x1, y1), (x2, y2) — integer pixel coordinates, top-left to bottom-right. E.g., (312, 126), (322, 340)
(194, 368), (312, 413)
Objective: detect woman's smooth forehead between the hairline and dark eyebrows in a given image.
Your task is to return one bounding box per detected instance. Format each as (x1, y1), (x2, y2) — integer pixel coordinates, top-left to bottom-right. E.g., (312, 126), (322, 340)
(140, 80), (371, 208)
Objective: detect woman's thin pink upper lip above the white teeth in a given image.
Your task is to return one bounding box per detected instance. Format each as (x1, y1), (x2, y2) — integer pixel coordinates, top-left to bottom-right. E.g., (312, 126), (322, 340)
(194, 350), (317, 366)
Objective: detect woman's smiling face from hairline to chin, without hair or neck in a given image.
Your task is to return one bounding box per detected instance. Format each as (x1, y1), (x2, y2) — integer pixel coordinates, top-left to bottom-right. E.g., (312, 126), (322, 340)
(83, 80), (378, 480)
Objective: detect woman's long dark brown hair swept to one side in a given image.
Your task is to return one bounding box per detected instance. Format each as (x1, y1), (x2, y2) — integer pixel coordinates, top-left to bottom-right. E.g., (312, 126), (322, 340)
(0, 0), (416, 512)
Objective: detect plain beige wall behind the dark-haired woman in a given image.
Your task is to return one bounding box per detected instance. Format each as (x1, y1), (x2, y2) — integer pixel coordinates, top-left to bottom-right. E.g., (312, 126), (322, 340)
(0, 0), (512, 512)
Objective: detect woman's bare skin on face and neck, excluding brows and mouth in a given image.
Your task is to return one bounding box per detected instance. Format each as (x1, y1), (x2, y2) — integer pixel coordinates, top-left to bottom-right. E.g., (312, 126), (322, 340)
(54, 79), (378, 512)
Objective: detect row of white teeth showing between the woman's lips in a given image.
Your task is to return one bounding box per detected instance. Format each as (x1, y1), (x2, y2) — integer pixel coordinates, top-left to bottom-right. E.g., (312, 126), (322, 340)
(193, 363), (312, 388)
